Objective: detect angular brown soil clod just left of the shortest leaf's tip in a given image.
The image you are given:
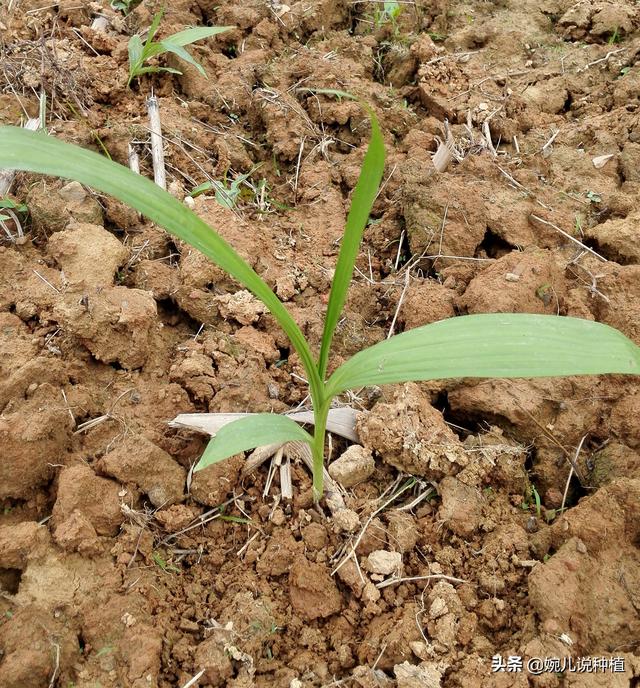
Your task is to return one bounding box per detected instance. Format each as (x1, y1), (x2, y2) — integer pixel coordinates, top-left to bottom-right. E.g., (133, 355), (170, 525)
(98, 435), (186, 507)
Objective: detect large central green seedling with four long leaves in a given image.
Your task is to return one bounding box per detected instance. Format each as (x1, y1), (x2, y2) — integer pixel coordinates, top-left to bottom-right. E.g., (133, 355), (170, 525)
(0, 90), (640, 499)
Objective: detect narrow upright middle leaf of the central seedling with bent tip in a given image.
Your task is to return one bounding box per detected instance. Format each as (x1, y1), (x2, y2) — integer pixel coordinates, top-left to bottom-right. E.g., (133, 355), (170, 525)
(314, 90), (385, 380)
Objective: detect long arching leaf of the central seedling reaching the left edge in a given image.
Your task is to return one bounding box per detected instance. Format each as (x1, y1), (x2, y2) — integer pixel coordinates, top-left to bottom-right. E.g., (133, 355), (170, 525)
(0, 127), (320, 394)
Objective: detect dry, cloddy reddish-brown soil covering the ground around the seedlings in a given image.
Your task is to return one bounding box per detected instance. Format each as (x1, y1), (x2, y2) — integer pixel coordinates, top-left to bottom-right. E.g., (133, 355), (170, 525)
(0, 0), (640, 688)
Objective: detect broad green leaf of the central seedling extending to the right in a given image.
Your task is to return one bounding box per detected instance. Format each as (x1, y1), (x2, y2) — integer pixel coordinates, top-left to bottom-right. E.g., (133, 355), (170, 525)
(326, 313), (640, 395)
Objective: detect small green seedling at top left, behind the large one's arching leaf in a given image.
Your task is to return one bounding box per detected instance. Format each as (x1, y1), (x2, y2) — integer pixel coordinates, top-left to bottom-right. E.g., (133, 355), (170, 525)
(127, 12), (234, 87)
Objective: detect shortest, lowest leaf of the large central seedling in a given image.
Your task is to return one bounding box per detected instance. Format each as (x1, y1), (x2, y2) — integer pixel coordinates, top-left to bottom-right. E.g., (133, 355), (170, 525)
(194, 413), (313, 471)
